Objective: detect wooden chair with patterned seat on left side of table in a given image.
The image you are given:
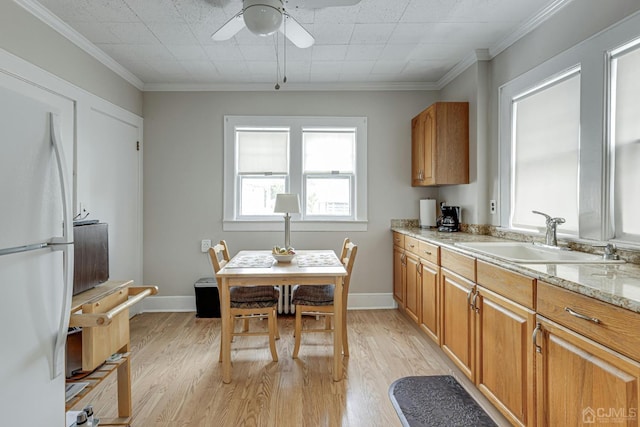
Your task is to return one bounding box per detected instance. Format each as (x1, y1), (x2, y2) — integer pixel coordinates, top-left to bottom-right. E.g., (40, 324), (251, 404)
(209, 240), (280, 362)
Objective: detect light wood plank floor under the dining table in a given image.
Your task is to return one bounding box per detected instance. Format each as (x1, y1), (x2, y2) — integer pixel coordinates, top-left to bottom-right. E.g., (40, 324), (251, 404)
(72, 310), (504, 427)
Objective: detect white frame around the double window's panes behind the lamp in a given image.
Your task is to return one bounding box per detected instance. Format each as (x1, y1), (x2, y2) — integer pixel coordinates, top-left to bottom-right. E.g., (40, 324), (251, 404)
(223, 116), (368, 231)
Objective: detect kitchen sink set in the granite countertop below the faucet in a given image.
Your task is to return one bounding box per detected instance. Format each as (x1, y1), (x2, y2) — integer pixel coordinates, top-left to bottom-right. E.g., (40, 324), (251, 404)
(455, 242), (624, 264)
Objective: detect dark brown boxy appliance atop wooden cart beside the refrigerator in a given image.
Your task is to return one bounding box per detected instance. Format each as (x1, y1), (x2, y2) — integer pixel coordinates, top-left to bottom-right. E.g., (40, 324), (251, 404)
(73, 221), (109, 295)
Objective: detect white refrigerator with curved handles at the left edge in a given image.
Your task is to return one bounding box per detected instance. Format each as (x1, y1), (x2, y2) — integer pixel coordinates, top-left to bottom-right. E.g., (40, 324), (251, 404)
(0, 81), (73, 427)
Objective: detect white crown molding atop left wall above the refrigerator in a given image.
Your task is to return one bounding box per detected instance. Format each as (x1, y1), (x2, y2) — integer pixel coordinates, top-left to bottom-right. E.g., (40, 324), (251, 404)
(13, 0), (144, 90)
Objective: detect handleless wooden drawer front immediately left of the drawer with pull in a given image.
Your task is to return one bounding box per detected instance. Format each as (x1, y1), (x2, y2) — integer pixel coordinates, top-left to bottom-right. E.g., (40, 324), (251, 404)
(477, 261), (536, 309)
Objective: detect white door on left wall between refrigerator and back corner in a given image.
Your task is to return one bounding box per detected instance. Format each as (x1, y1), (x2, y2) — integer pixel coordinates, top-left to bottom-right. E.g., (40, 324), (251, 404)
(78, 107), (142, 284)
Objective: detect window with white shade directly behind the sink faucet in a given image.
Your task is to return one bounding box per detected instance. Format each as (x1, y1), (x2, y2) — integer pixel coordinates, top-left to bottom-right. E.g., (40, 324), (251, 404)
(510, 70), (580, 234)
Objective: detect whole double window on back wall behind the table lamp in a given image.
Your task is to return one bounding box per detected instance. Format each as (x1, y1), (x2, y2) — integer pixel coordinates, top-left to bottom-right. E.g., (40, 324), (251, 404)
(224, 116), (367, 231)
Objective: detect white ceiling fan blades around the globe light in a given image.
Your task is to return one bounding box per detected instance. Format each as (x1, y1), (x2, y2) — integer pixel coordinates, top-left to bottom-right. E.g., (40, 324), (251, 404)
(211, 0), (360, 48)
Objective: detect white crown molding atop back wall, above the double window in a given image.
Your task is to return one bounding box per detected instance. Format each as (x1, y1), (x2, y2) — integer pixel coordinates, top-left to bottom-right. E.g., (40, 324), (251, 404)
(144, 82), (439, 92)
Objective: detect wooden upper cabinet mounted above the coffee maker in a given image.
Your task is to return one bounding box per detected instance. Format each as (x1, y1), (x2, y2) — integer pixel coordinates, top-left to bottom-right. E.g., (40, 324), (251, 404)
(411, 102), (469, 187)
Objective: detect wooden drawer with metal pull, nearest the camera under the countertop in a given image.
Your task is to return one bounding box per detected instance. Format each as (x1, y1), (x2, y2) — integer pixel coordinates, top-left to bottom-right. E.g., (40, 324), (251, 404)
(536, 281), (640, 361)
